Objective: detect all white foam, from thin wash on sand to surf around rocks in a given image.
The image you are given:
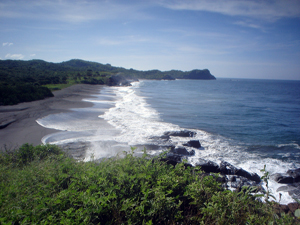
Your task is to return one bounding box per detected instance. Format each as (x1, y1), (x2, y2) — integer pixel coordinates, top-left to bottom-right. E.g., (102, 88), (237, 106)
(37, 81), (300, 204)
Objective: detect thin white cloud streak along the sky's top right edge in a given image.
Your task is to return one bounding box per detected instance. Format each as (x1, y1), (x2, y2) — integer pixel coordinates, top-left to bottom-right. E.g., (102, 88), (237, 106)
(160, 0), (300, 21)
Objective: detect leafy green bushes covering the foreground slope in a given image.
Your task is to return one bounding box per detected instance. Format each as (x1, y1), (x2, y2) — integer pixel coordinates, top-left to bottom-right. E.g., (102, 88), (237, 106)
(0, 144), (297, 224)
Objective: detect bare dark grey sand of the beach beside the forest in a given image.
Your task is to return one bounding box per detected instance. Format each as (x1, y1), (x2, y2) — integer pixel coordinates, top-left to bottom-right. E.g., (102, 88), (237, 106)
(0, 84), (101, 150)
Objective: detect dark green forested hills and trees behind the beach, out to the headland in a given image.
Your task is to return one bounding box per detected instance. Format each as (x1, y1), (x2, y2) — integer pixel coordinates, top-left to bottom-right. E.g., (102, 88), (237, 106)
(0, 59), (216, 105)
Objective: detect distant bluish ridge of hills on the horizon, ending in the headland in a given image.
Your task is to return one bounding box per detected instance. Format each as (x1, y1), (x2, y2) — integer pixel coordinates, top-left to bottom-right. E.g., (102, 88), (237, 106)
(0, 59), (216, 82)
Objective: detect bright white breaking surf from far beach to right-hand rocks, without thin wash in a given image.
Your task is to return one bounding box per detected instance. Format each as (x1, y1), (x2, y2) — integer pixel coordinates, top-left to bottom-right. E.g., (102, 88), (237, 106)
(99, 83), (300, 203)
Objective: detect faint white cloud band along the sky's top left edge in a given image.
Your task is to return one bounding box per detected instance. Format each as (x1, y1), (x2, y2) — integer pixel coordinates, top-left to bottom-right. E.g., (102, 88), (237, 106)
(0, 0), (149, 23)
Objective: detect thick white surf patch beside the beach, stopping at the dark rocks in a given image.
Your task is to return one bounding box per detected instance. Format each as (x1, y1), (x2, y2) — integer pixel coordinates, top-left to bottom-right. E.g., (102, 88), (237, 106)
(99, 83), (179, 145)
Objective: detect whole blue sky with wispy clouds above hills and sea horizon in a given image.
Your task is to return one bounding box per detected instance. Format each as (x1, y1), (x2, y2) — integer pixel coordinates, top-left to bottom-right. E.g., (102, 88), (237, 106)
(0, 0), (300, 80)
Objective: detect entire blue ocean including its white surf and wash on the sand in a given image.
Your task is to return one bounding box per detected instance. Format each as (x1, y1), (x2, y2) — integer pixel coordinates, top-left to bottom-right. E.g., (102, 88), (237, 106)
(37, 78), (300, 203)
